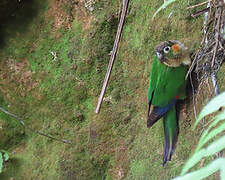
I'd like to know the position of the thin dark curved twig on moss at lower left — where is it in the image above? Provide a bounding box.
[0,107,72,144]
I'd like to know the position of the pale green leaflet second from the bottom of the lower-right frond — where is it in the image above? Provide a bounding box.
[181,136,225,175]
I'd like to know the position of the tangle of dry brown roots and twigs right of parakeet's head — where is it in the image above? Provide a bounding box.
[186,0,225,100]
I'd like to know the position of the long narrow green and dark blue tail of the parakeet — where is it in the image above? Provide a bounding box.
[163,105,179,166]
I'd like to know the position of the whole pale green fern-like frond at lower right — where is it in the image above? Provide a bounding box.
[174,92,225,180]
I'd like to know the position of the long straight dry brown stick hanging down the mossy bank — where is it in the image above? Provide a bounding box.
[95,0,129,113]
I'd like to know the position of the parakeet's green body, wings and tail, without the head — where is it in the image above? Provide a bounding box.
[147,57,187,165]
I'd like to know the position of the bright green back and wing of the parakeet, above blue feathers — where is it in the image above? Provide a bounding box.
[148,57,187,107]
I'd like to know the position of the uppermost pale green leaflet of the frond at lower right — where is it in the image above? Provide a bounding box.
[194,92,225,128]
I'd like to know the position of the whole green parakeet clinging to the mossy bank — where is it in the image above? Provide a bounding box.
[147,40,191,166]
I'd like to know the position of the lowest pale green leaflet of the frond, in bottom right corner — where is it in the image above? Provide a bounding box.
[173,158,225,180]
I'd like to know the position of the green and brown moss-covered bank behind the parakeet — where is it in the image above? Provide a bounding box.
[0,0,223,180]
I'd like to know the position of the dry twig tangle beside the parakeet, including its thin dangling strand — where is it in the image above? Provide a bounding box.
[186,0,224,124]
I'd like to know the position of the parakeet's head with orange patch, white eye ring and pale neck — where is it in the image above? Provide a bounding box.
[155,40,191,67]
